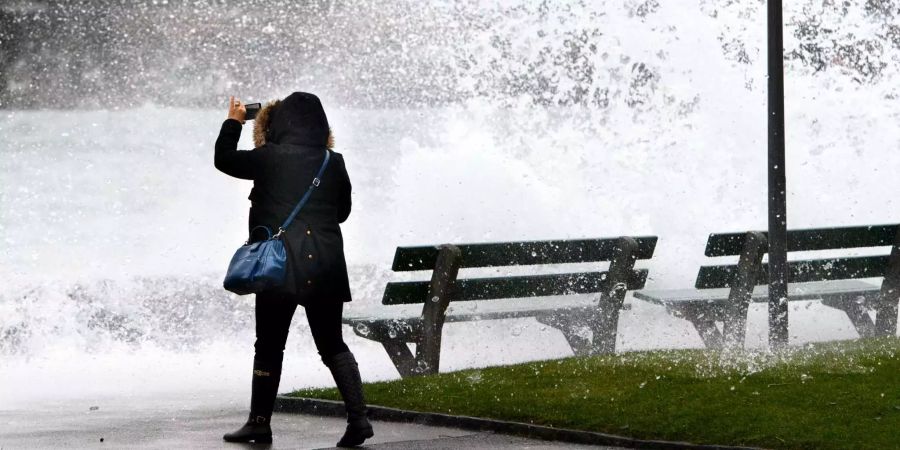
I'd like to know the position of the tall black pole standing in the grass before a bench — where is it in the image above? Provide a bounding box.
[768,0,788,349]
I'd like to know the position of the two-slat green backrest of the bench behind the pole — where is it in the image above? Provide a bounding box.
[695,225,898,289]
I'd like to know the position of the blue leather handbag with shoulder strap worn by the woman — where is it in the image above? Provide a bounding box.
[223,150,331,295]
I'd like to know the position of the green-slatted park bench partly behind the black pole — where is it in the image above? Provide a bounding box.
[634,225,900,348]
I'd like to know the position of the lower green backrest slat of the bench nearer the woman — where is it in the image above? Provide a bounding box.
[381,269,647,305]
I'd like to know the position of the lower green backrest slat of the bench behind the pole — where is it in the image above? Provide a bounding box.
[694,255,893,289]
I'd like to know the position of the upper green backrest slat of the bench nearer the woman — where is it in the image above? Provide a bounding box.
[391,236,657,272]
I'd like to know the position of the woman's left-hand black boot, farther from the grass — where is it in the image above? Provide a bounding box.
[222,360,281,443]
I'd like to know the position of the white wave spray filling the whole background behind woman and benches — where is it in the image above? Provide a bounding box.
[0,0,900,405]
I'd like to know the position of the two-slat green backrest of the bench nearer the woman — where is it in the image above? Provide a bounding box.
[382,236,657,305]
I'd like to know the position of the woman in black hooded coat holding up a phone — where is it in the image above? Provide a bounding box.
[215,92,373,447]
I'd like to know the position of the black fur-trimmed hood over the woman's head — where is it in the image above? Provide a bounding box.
[253,92,329,147]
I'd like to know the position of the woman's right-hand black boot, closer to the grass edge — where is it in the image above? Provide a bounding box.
[323,352,375,447]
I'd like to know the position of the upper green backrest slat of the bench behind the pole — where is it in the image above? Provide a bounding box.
[706,224,897,256]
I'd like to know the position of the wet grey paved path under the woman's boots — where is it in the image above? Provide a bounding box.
[0,400,620,450]
